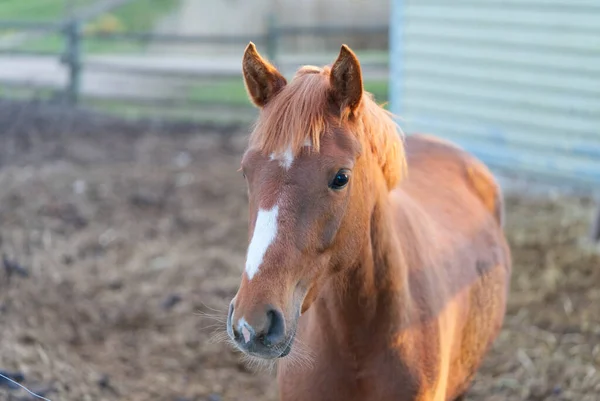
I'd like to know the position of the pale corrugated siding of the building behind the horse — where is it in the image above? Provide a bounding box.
[390,0,600,187]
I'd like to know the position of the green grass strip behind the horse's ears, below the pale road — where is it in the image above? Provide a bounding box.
[188,78,388,106]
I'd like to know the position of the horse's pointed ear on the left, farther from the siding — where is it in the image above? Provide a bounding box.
[242,42,287,108]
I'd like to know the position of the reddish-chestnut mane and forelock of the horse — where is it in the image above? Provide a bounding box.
[250,66,406,189]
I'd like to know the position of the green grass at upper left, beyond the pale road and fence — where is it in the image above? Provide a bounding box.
[0,0,180,53]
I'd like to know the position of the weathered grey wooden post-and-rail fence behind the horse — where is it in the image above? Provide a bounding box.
[0,0,388,121]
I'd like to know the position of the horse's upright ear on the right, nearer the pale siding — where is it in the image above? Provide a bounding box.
[329,45,363,114]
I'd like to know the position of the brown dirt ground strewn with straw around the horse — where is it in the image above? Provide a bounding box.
[0,104,600,401]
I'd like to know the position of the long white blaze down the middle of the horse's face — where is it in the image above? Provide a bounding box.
[246,205,279,281]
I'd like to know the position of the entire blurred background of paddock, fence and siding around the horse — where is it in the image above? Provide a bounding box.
[0,0,600,401]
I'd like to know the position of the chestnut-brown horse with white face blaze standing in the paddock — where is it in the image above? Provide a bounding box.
[227,43,511,401]
